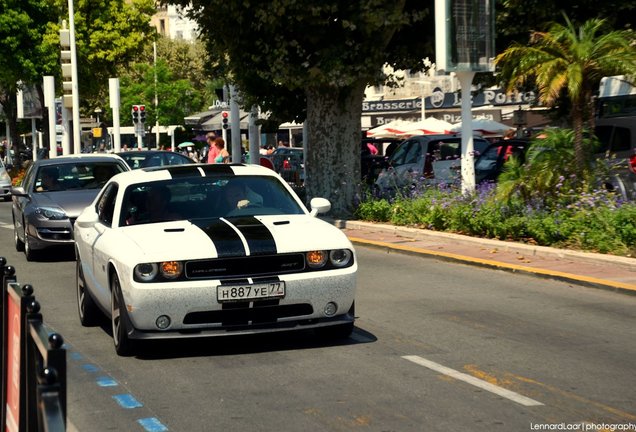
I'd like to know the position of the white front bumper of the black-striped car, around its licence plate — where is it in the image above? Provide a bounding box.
[122,268,356,339]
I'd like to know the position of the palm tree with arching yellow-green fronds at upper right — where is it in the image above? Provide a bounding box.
[495,14,636,172]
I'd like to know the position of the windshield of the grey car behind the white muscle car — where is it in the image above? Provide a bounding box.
[33,161,124,192]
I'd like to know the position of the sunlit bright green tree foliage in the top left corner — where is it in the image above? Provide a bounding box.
[0,0,156,158]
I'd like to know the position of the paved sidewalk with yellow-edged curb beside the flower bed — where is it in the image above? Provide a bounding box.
[331,220,636,295]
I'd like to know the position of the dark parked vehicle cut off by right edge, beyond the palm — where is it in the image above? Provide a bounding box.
[594,116,636,201]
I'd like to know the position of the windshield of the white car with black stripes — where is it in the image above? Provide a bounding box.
[119,176,304,226]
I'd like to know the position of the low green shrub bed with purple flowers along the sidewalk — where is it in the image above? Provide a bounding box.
[357,182,636,256]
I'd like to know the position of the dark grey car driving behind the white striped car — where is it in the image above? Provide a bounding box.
[11,154,130,261]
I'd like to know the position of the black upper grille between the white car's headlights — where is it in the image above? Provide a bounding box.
[185,253,305,279]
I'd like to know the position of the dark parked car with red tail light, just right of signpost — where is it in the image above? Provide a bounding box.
[475,138,530,183]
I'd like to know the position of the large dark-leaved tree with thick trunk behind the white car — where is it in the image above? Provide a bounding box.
[169,0,434,216]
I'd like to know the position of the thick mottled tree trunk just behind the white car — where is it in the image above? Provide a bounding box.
[305,83,364,218]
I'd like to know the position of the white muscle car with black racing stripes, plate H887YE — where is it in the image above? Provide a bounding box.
[75,164,357,355]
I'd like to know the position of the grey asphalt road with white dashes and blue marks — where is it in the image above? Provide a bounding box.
[0,203,636,432]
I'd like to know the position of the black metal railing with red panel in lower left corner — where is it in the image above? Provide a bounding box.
[0,257,66,432]
